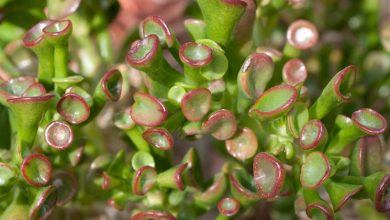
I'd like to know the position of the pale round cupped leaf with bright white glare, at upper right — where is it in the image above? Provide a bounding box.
[287,20,318,50]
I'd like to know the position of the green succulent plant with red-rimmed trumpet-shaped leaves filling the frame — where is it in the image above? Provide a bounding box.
[0,0,390,220]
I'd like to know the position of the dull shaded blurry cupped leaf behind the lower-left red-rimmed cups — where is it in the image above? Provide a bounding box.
[51,170,78,206]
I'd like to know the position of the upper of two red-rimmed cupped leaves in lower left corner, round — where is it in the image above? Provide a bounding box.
[20,154,52,187]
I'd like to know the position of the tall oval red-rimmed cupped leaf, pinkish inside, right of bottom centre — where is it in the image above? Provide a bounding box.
[253,153,285,199]
